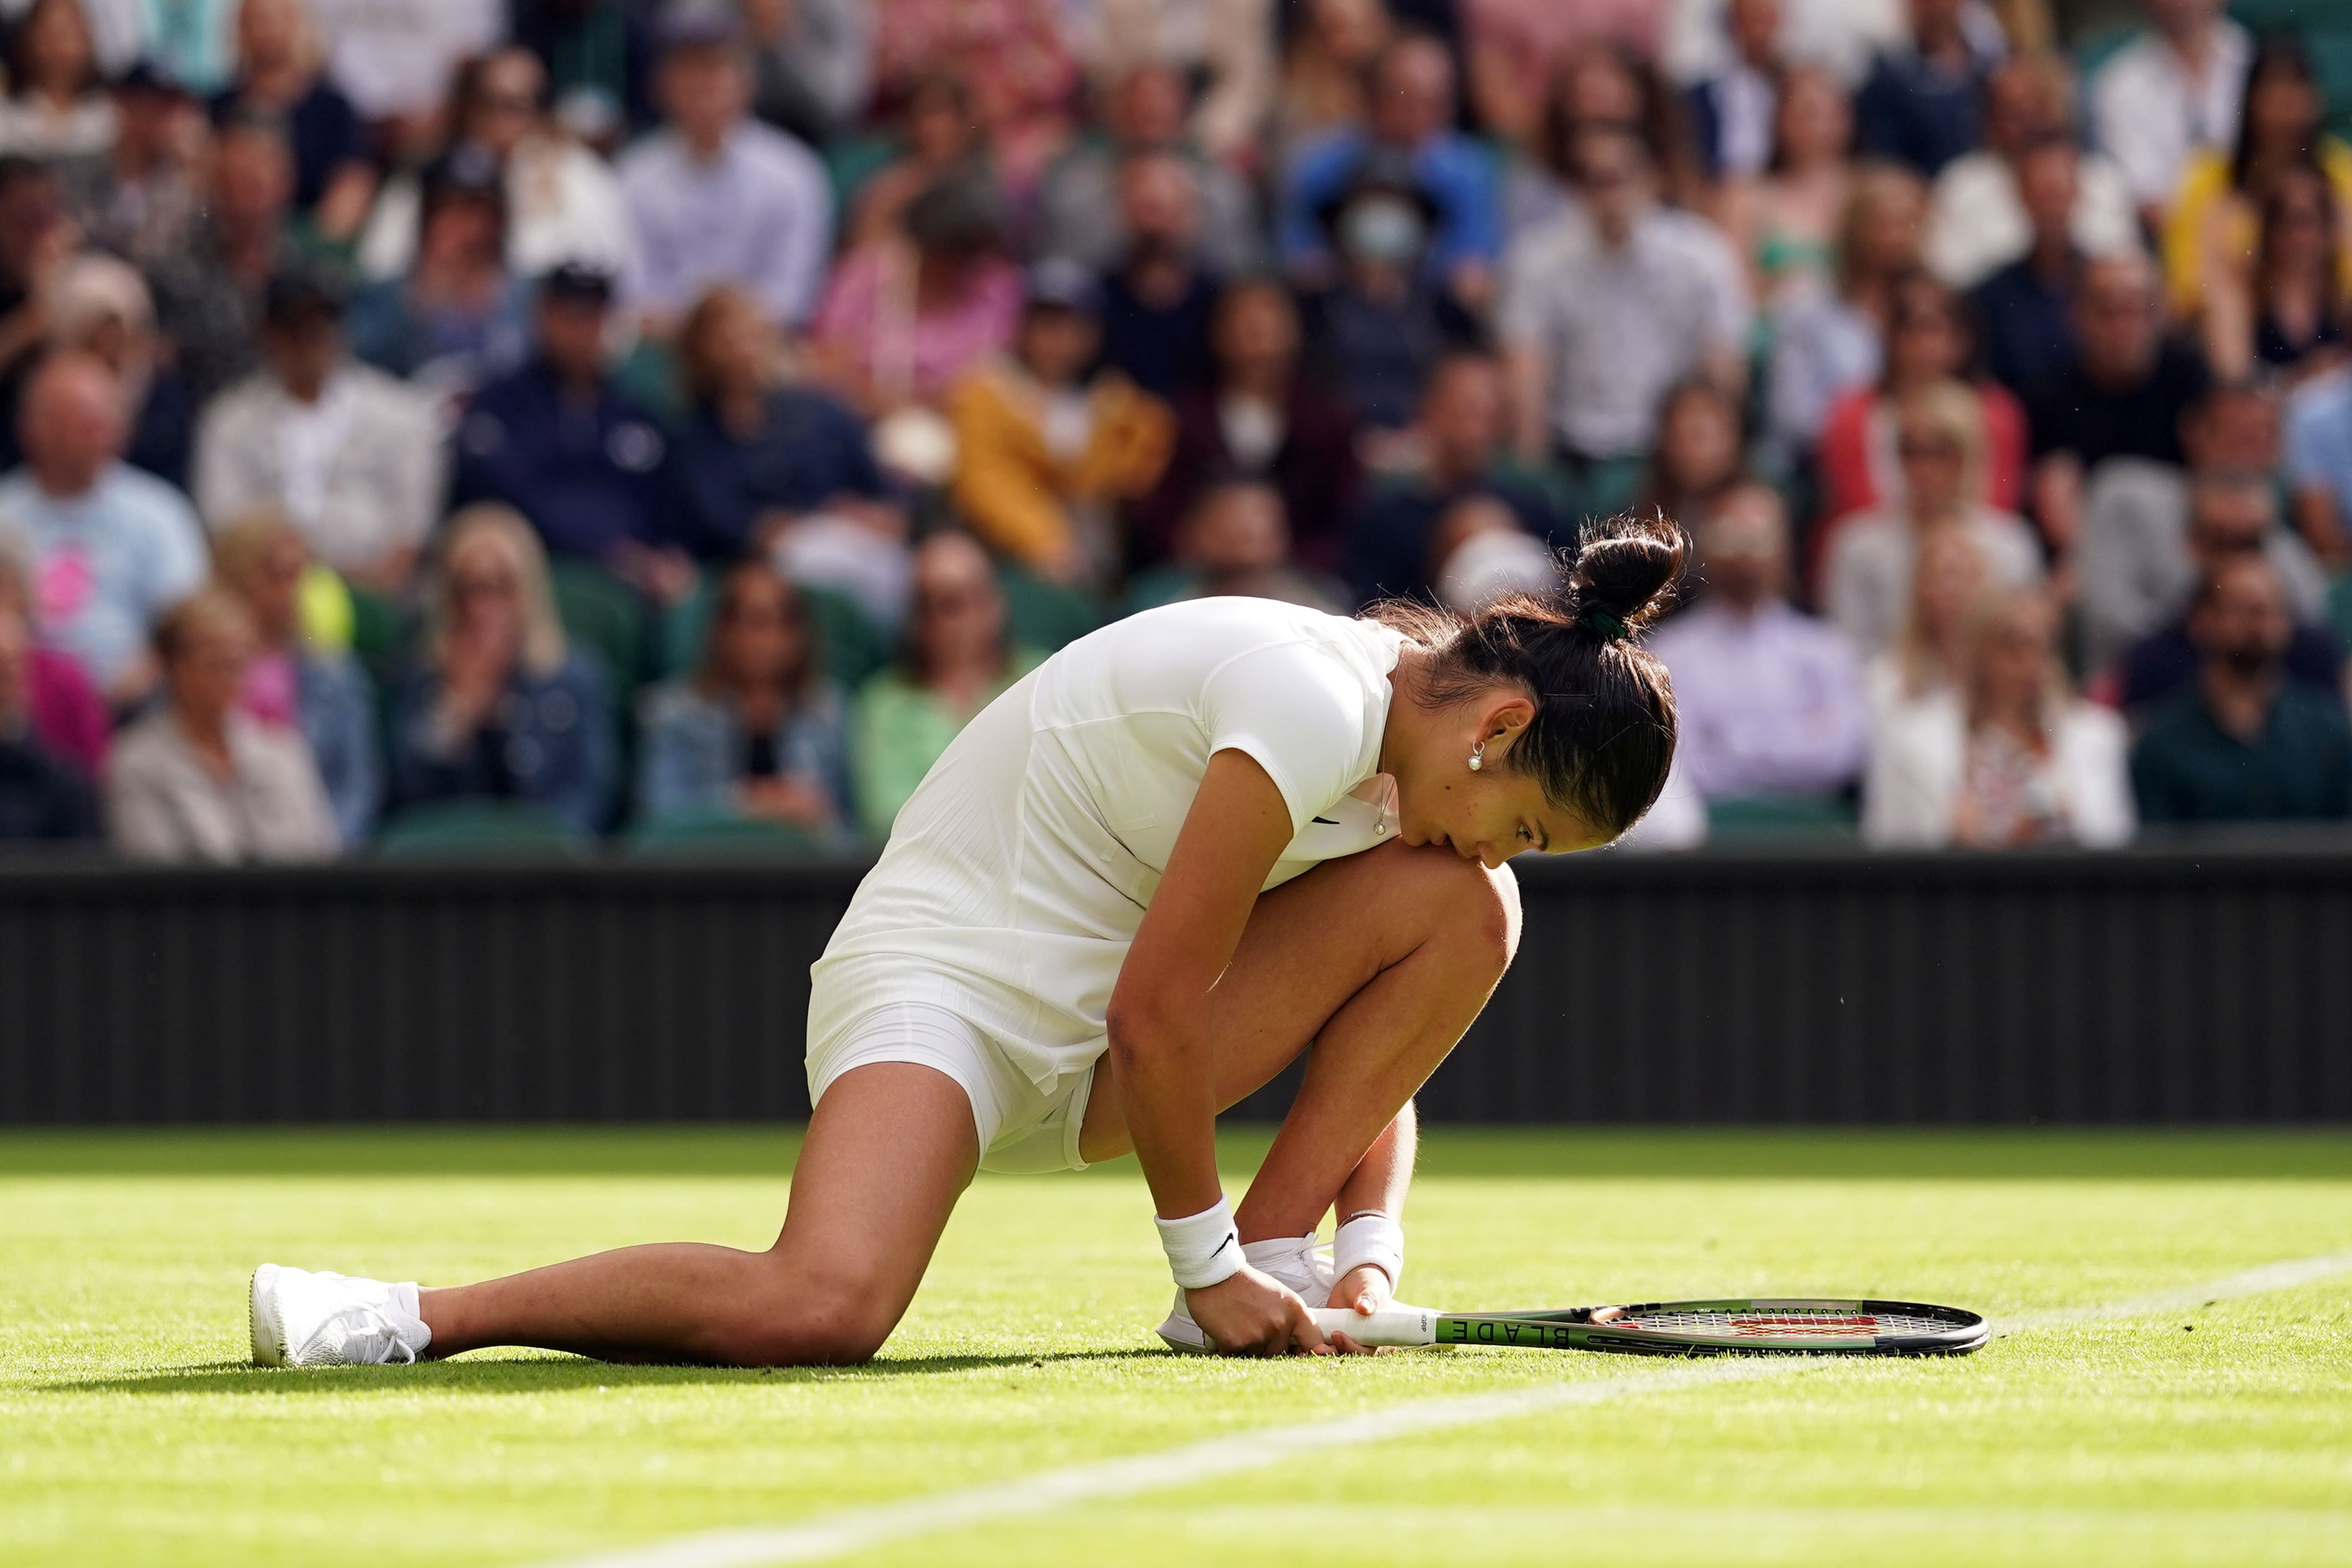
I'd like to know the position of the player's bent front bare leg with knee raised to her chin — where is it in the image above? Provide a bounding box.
[1079,844,1520,1241]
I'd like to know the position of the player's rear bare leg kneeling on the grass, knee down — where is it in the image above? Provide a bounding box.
[421,1063,981,1366]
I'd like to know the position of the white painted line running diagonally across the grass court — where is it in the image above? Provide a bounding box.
[533,1253,2352,1568]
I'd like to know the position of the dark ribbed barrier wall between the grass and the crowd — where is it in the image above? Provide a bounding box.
[0,844,2352,1123]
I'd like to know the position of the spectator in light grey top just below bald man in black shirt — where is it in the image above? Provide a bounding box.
[2079,383,2326,677]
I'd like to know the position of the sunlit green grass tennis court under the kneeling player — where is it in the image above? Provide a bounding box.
[0,1128,2352,1568]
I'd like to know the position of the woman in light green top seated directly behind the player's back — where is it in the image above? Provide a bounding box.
[849,532,1037,837]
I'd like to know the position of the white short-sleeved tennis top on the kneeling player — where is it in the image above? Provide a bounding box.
[809,597,1404,1089]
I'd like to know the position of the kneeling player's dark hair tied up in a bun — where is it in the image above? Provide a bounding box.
[1373,515,1691,837]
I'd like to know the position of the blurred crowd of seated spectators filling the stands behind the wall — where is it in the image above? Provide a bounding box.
[0,0,2352,860]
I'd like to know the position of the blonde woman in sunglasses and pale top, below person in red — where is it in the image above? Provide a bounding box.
[1823,381,2042,656]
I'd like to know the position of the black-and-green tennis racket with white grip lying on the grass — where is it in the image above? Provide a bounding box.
[1312,1298,1992,1357]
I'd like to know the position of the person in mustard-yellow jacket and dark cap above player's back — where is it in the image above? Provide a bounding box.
[948,261,1176,585]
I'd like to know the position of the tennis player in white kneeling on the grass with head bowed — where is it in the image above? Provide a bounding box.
[252,517,1686,1366]
